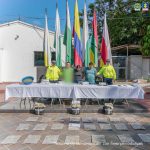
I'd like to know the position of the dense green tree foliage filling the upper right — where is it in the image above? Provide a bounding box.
[80,0,150,56]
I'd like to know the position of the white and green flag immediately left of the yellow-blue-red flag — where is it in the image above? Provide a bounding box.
[63,0,72,63]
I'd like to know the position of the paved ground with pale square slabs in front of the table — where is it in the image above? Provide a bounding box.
[0,113,150,150]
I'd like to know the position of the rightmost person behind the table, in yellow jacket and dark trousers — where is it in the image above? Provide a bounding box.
[97,59,116,85]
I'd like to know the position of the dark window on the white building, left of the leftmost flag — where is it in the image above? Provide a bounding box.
[34,52,44,66]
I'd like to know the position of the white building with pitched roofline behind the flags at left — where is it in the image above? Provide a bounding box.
[0,21,65,82]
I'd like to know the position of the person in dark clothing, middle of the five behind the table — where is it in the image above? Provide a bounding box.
[74,65,83,83]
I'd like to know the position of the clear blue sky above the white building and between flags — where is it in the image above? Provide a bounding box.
[0,0,94,32]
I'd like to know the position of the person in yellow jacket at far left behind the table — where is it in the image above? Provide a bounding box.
[46,60,61,82]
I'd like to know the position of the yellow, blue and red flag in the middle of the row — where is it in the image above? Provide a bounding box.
[73,0,82,66]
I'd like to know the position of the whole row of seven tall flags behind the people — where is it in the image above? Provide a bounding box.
[43,0,112,67]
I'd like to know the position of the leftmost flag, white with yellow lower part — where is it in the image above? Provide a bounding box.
[43,12,51,67]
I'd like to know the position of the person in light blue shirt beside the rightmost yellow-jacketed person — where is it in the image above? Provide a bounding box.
[84,62,97,84]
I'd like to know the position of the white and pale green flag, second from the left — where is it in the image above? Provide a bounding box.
[54,3,62,67]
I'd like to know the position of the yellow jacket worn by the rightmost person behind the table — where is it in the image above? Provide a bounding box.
[97,65,116,80]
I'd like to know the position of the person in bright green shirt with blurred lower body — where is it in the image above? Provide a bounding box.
[62,62,73,83]
